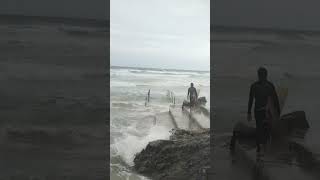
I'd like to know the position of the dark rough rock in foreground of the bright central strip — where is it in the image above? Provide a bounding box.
[134,129,210,179]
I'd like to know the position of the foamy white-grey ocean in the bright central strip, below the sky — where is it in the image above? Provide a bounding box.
[110,67,210,180]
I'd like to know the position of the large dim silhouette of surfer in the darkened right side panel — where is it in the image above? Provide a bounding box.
[248,67,280,152]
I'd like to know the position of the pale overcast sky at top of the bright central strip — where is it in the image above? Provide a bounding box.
[110,0,210,70]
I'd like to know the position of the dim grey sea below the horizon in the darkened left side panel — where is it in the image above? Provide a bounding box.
[0,17,109,180]
